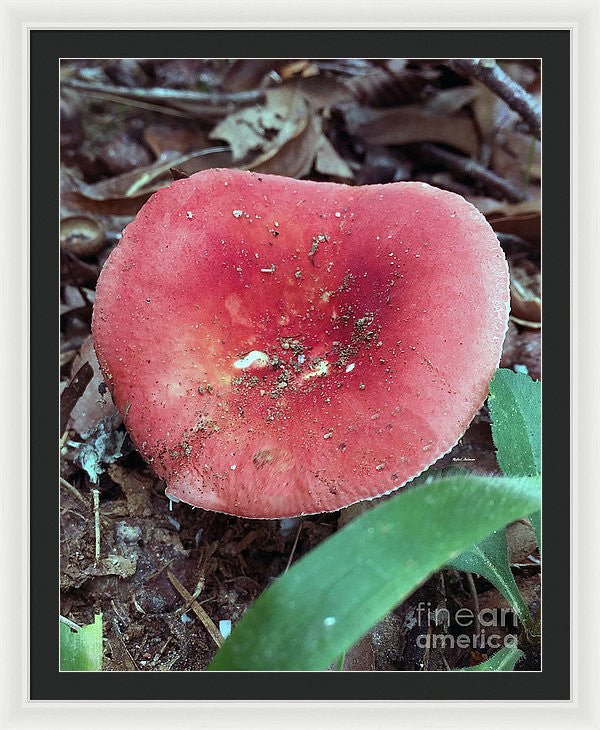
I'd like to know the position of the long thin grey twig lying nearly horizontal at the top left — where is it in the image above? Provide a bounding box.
[62,79,265,107]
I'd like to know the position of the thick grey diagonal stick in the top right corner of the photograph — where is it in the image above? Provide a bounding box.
[451,58,542,139]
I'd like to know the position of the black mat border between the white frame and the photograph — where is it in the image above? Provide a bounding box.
[32,30,571,700]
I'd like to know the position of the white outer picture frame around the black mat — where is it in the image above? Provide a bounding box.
[0,0,600,730]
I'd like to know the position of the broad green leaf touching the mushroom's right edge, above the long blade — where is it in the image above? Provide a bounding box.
[488,368,542,476]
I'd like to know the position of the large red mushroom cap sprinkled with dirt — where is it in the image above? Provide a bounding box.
[92,169,509,518]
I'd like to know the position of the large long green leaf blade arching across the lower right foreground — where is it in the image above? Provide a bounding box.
[208,474,540,671]
